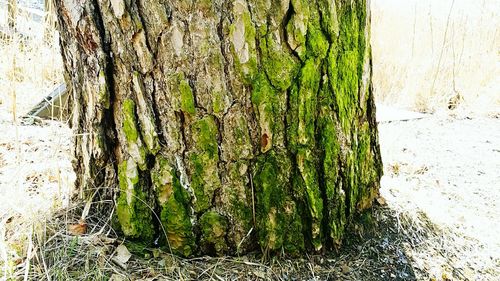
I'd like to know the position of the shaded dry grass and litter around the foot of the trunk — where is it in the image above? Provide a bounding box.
[19,199,420,280]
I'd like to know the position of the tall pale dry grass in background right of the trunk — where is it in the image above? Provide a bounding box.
[372,0,500,115]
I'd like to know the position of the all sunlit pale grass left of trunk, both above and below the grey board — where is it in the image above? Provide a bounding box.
[0,1,73,280]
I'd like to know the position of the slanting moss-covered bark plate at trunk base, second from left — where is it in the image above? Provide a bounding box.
[151,156,196,257]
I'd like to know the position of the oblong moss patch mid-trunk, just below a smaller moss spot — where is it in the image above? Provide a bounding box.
[188,116,221,212]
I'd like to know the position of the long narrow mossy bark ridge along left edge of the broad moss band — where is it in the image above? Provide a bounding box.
[287,24,329,250]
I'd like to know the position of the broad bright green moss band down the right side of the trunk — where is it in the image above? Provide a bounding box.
[287,0,373,249]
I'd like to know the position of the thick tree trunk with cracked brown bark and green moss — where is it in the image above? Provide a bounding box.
[56,0,382,256]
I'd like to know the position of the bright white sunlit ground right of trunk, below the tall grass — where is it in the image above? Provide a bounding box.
[379,108,500,280]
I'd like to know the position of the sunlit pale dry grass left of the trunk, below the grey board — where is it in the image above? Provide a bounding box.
[0,120,74,280]
